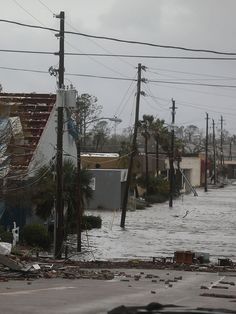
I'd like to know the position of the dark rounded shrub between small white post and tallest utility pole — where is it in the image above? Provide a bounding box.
[22,224,50,250]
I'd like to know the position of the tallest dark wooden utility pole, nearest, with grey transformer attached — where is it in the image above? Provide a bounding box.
[54,11,65,258]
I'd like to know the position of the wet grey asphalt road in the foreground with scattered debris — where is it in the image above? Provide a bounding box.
[0,270,236,314]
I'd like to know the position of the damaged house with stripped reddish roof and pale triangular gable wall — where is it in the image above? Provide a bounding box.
[0,93,76,228]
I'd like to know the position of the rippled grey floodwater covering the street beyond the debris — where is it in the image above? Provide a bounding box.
[73,185,236,260]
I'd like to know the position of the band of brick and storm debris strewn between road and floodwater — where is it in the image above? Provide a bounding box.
[0,254,236,285]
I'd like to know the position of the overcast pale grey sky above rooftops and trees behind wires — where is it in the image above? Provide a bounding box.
[0,0,236,134]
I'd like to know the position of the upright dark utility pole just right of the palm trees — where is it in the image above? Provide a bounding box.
[169,99,177,207]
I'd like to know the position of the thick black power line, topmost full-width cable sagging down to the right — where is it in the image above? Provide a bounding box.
[0,19,236,56]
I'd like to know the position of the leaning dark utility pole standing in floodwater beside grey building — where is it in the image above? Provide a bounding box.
[120,63,145,228]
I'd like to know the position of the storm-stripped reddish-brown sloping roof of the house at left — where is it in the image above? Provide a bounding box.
[0,93,56,180]
